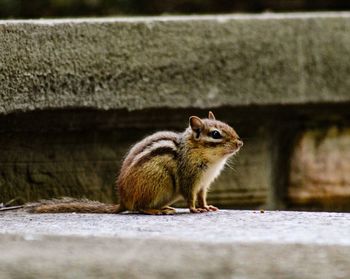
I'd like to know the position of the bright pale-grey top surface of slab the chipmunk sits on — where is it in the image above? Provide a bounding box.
[0,209,350,246]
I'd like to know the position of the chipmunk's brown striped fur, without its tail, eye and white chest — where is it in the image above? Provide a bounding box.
[117,112,242,214]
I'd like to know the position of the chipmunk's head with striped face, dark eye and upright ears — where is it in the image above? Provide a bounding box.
[189,111,243,160]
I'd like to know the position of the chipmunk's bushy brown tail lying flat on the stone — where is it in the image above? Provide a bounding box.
[24,198,126,214]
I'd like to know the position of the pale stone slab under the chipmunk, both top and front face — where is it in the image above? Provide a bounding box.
[0,210,350,279]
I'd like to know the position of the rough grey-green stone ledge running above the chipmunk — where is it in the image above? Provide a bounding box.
[0,12,350,114]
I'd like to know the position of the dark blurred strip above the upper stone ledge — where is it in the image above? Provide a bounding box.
[0,0,350,19]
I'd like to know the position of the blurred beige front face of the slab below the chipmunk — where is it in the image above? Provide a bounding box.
[0,235,350,279]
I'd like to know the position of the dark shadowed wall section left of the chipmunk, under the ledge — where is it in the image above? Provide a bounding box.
[0,131,131,206]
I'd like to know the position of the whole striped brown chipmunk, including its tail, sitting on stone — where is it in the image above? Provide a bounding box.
[32,111,243,215]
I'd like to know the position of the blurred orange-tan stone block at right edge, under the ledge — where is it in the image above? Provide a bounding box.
[288,126,350,209]
